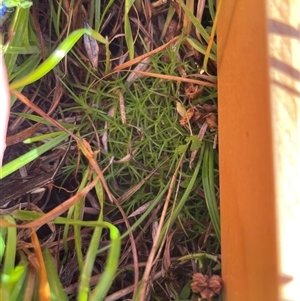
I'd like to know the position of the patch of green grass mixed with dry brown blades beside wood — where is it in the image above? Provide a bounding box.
[0,0,221,301]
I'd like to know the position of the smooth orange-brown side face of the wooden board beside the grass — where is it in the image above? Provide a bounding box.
[218,0,279,301]
